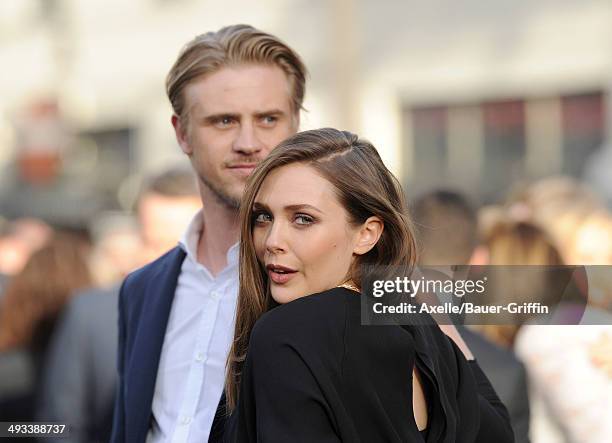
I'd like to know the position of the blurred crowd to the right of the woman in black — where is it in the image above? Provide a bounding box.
[413,177,612,443]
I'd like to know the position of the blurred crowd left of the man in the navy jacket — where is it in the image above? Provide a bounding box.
[0,169,201,442]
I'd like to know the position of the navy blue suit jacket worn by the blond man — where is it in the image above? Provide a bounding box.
[111,247,225,443]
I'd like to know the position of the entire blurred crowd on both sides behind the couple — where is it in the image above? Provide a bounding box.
[0,169,612,443]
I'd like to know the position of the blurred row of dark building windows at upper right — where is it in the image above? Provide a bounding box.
[403,91,605,203]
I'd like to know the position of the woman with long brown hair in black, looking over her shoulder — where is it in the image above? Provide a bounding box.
[226,129,513,443]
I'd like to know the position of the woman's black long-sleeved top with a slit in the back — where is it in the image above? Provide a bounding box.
[226,288,514,443]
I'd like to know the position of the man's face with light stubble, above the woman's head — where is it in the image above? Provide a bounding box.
[173,64,298,208]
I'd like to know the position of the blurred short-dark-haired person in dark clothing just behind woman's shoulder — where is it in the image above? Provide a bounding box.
[412,190,530,442]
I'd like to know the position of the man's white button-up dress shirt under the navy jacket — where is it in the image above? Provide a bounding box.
[147,212,238,443]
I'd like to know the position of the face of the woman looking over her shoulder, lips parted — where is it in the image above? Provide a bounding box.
[253,163,380,303]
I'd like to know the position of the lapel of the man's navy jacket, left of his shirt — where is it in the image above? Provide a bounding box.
[127,247,185,442]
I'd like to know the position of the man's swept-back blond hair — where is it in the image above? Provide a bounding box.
[166,25,306,125]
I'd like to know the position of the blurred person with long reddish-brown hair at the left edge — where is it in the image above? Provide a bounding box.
[0,232,92,421]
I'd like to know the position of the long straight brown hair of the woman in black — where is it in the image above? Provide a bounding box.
[226,128,416,410]
